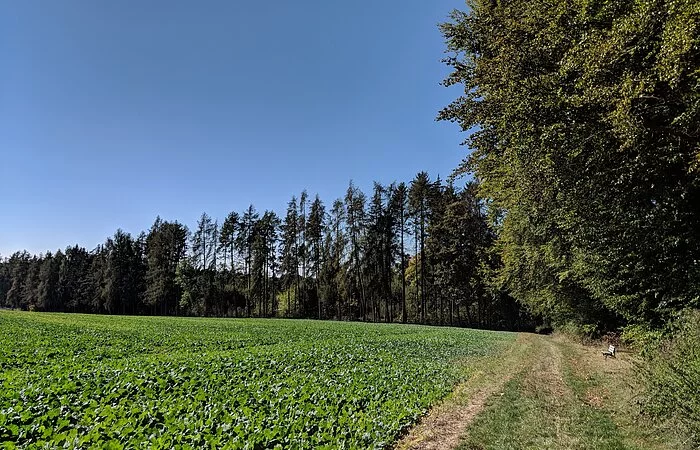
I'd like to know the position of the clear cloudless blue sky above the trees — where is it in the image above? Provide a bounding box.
[0,0,465,256]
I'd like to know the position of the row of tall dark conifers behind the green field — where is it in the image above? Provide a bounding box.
[0,172,530,329]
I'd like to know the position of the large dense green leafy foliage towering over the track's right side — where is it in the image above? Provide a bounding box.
[439,0,700,328]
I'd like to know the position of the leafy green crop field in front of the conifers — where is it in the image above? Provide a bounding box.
[0,311,514,449]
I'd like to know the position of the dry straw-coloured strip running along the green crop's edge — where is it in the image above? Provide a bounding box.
[395,334,536,450]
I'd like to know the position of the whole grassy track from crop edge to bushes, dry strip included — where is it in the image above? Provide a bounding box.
[397,334,683,450]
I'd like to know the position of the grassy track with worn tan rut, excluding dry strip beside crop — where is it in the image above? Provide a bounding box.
[454,335,682,450]
